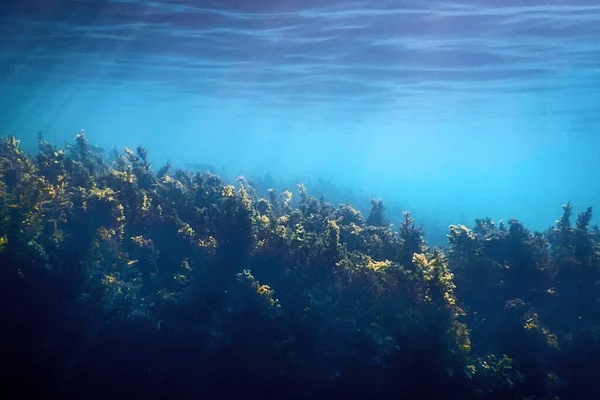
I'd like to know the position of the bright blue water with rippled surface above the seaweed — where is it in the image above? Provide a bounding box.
[0,0,600,242]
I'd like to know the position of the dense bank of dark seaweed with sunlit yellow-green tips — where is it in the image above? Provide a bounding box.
[0,132,600,399]
